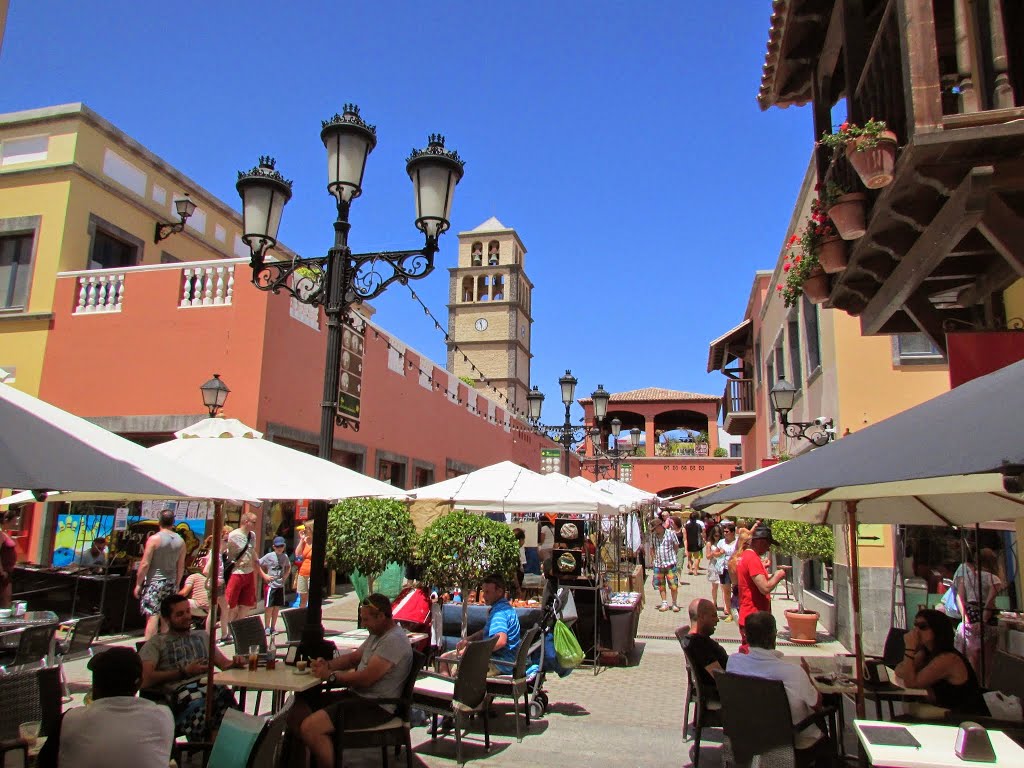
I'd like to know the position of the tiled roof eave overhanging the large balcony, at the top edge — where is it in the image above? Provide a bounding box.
[758,0,835,110]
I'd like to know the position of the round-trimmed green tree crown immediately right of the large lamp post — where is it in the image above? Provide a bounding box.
[327,499,416,592]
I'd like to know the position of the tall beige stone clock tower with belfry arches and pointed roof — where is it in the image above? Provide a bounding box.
[447,216,534,414]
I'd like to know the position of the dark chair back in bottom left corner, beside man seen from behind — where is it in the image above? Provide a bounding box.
[0,667,61,765]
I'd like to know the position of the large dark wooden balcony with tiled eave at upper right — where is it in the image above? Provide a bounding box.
[760,0,1024,349]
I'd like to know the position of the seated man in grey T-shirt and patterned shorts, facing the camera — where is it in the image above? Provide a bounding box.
[138,595,243,741]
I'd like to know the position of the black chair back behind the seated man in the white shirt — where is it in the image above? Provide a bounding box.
[715,672,839,768]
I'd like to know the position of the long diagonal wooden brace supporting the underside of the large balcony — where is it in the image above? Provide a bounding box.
[860,166,995,336]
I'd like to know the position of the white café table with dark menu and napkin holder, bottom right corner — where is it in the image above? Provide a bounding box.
[853,720,1024,768]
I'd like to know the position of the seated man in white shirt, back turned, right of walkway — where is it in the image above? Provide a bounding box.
[725,610,826,751]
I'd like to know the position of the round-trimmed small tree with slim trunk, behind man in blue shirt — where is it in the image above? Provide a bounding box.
[419,510,519,637]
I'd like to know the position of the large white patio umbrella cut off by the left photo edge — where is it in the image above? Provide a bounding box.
[0,385,256,503]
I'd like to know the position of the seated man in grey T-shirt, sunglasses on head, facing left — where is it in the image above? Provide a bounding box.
[289,593,413,768]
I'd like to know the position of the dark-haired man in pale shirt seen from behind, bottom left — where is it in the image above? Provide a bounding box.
[37,647,174,768]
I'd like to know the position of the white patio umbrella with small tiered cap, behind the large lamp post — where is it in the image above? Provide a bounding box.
[150,418,395,501]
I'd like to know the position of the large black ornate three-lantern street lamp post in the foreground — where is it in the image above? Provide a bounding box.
[236,104,465,656]
